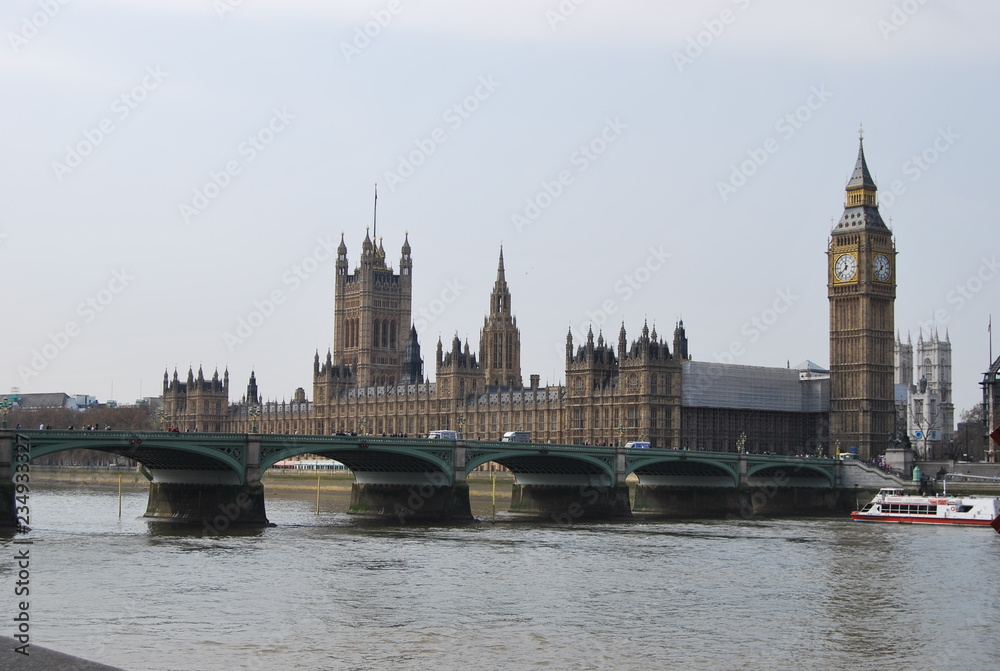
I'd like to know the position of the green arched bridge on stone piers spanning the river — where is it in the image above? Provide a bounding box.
[0,429,868,525]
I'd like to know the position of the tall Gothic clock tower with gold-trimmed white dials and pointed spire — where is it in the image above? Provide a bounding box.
[827,137,896,459]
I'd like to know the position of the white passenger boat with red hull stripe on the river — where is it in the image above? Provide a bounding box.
[851,488,1000,531]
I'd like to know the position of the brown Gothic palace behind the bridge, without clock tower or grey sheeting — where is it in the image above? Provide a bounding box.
[164,228,825,453]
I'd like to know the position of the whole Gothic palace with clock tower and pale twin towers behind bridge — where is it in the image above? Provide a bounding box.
[163,142,954,458]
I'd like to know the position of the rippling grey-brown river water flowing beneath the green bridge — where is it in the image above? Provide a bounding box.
[0,487,1000,671]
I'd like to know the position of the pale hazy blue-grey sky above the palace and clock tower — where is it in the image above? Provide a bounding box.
[0,0,1000,415]
